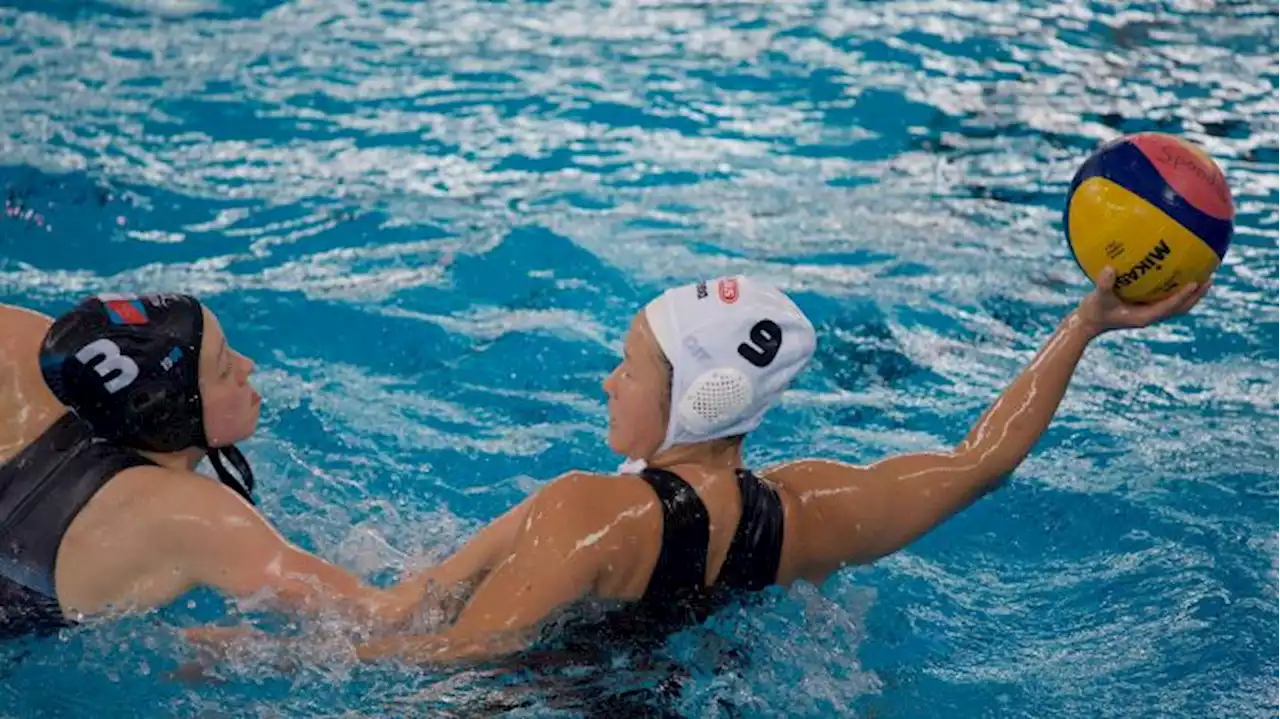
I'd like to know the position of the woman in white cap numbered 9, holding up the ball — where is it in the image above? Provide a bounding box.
[345,271,1208,661]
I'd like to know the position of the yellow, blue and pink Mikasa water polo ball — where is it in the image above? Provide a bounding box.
[1062,133,1235,303]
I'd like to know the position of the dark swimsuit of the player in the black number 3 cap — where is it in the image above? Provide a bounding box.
[0,413,154,640]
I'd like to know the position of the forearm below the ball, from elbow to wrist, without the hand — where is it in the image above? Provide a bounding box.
[956,307,1098,481]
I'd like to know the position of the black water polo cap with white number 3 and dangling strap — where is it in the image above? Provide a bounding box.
[40,294,253,502]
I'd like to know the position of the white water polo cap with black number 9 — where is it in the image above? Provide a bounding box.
[645,275,817,452]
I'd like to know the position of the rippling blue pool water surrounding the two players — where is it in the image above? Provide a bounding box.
[0,0,1280,718]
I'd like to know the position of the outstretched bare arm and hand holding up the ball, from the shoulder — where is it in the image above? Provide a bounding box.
[785,269,1208,578]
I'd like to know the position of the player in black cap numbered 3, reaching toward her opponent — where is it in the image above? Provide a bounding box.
[0,294,422,636]
